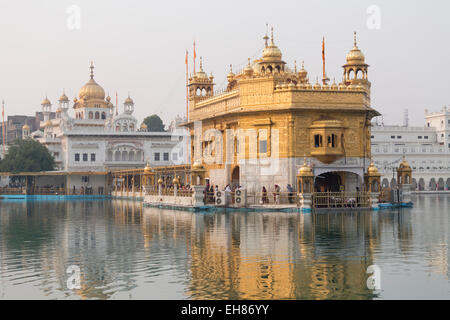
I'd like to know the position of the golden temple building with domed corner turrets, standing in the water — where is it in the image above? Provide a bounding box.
[185,31,379,191]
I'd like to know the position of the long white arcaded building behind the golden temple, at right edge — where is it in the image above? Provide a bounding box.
[372,107,450,190]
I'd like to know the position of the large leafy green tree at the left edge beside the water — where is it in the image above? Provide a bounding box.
[0,139,55,173]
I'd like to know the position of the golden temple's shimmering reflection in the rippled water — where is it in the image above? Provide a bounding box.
[138,208,380,299]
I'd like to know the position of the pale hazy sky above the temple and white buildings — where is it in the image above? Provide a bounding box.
[0,0,450,125]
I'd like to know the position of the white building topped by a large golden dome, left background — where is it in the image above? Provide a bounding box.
[28,65,186,172]
